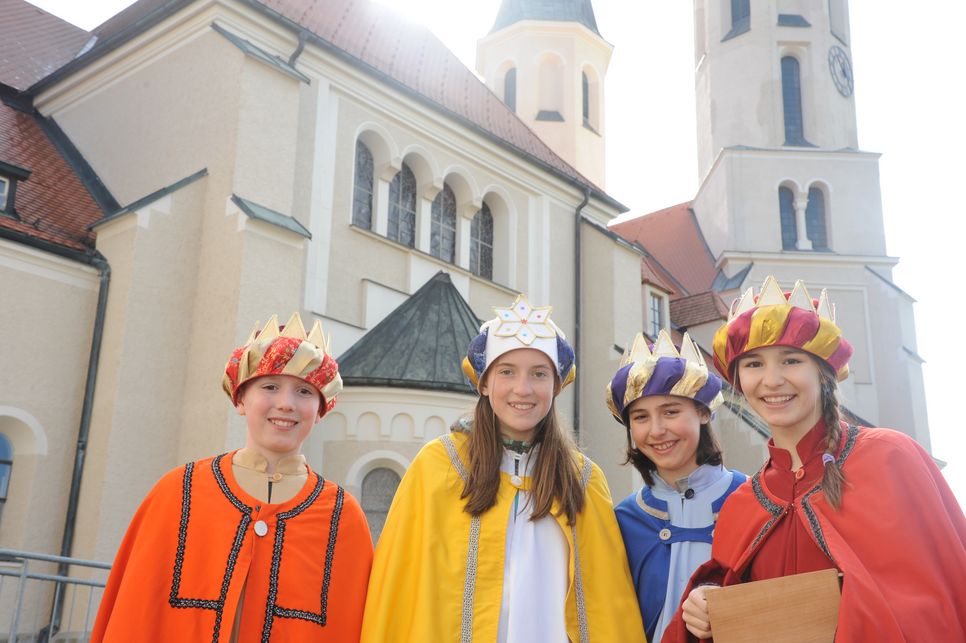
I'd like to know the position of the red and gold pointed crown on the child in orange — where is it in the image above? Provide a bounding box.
[221,313,342,417]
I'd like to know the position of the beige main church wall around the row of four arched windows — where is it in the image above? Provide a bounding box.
[15,2,641,584]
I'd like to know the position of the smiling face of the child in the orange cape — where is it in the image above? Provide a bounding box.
[235,375,322,462]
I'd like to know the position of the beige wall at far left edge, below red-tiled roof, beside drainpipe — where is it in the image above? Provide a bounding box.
[0,240,99,553]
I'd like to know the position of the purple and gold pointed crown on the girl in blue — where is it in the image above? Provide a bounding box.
[607,330,723,424]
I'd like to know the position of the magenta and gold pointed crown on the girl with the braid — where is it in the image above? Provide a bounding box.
[714,276,852,384]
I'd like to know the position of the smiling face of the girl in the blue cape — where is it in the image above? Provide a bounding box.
[627,395,711,484]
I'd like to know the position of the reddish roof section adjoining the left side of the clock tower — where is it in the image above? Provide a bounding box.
[610,202,718,296]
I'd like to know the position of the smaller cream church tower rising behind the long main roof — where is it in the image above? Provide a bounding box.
[476,0,613,188]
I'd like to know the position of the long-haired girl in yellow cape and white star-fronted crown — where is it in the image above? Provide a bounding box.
[362,295,644,643]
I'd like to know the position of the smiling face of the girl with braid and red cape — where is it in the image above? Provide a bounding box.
[735,346,822,448]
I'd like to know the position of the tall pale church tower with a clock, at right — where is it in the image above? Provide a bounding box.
[692,0,929,448]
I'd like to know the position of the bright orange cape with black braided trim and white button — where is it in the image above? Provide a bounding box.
[91,454,372,643]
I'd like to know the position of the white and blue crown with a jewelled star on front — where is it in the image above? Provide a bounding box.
[463,295,577,391]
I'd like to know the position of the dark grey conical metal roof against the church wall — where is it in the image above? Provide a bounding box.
[338,271,480,393]
